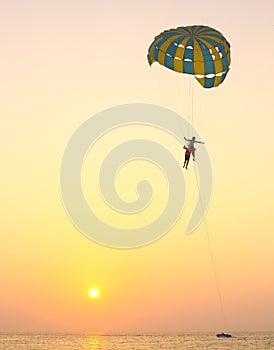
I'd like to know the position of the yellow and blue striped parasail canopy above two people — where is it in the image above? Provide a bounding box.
[147,25,230,88]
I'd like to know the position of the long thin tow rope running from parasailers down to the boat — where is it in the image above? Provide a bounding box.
[193,162,226,329]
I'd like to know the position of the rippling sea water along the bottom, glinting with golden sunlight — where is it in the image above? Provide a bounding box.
[0,332,274,350]
